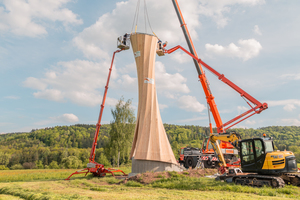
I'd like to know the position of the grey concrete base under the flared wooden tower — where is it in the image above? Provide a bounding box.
[131,158,185,175]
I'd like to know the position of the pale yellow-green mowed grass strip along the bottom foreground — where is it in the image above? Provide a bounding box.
[0,179,299,200]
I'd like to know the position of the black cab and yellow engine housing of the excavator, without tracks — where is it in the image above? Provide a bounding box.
[240,137,298,174]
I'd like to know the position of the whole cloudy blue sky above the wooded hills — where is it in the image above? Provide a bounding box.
[0,0,300,134]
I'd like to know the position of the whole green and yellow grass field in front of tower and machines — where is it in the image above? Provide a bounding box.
[0,167,300,200]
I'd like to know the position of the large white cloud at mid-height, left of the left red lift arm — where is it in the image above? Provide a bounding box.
[24,60,117,106]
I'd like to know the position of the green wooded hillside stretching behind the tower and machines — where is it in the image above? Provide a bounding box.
[0,124,300,170]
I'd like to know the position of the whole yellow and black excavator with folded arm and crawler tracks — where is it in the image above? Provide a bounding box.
[210,132,300,188]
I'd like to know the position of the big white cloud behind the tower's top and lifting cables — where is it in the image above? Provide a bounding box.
[73,0,264,62]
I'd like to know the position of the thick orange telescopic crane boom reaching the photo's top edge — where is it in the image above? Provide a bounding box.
[172,0,224,133]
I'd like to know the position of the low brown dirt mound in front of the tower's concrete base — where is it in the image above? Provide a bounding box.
[124,168,218,184]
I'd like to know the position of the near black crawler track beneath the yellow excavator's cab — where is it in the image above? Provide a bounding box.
[232,174,285,188]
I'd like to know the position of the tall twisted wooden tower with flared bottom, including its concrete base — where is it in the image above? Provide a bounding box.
[130,33,178,173]
